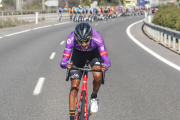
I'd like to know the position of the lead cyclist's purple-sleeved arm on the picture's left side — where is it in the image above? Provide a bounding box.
[60,31,74,68]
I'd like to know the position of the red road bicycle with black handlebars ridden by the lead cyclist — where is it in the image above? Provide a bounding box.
[66,61,105,120]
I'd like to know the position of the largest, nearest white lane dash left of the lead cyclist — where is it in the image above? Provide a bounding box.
[33,77,45,95]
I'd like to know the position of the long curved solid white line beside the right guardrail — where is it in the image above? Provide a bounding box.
[126,20,180,71]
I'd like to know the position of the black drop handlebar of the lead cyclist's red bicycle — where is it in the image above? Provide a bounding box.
[66,67,105,84]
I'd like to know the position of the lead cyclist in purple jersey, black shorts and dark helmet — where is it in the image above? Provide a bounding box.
[60,22,111,120]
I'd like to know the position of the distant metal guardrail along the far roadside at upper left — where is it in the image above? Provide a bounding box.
[0,9,68,15]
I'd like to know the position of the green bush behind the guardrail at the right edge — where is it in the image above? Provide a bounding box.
[152,4,180,31]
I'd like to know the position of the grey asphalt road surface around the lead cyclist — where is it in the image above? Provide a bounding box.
[0,16,180,120]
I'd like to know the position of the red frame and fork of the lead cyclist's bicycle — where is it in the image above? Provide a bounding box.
[76,72,89,120]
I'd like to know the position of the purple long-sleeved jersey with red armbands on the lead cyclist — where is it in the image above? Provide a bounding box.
[60,28,111,71]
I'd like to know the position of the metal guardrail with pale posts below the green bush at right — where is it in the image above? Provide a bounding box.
[143,15,180,53]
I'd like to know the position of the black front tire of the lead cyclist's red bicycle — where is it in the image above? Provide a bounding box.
[78,91,86,120]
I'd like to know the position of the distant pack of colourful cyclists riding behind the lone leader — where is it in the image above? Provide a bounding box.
[69,5,145,22]
